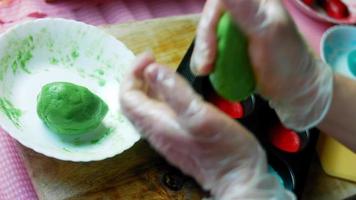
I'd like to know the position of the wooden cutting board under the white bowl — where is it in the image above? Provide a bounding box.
[21,15,202,200]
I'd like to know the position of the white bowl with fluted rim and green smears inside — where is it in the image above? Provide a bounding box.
[0,19,140,161]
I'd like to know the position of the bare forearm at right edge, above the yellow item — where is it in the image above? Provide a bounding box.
[318,74,356,152]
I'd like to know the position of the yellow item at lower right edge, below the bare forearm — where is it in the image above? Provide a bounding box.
[317,134,356,182]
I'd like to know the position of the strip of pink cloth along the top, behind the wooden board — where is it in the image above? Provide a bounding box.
[0,0,205,31]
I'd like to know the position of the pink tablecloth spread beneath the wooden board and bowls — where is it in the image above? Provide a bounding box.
[0,0,331,200]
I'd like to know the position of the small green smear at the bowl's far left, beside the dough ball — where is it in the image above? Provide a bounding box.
[0,98,22,128]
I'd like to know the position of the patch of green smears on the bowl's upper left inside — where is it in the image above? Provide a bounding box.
[0,35,35,80]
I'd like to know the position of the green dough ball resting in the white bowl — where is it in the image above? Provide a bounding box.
[37,82,108,135]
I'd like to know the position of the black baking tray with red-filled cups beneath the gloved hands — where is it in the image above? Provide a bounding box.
[177,43,319,199]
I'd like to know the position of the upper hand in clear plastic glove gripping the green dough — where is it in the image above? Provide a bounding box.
[191,0,333,131]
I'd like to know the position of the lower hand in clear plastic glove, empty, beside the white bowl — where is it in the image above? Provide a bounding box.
[120,54,294,200]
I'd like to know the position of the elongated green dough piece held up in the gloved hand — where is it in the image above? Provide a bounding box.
[209,13,255,101]
